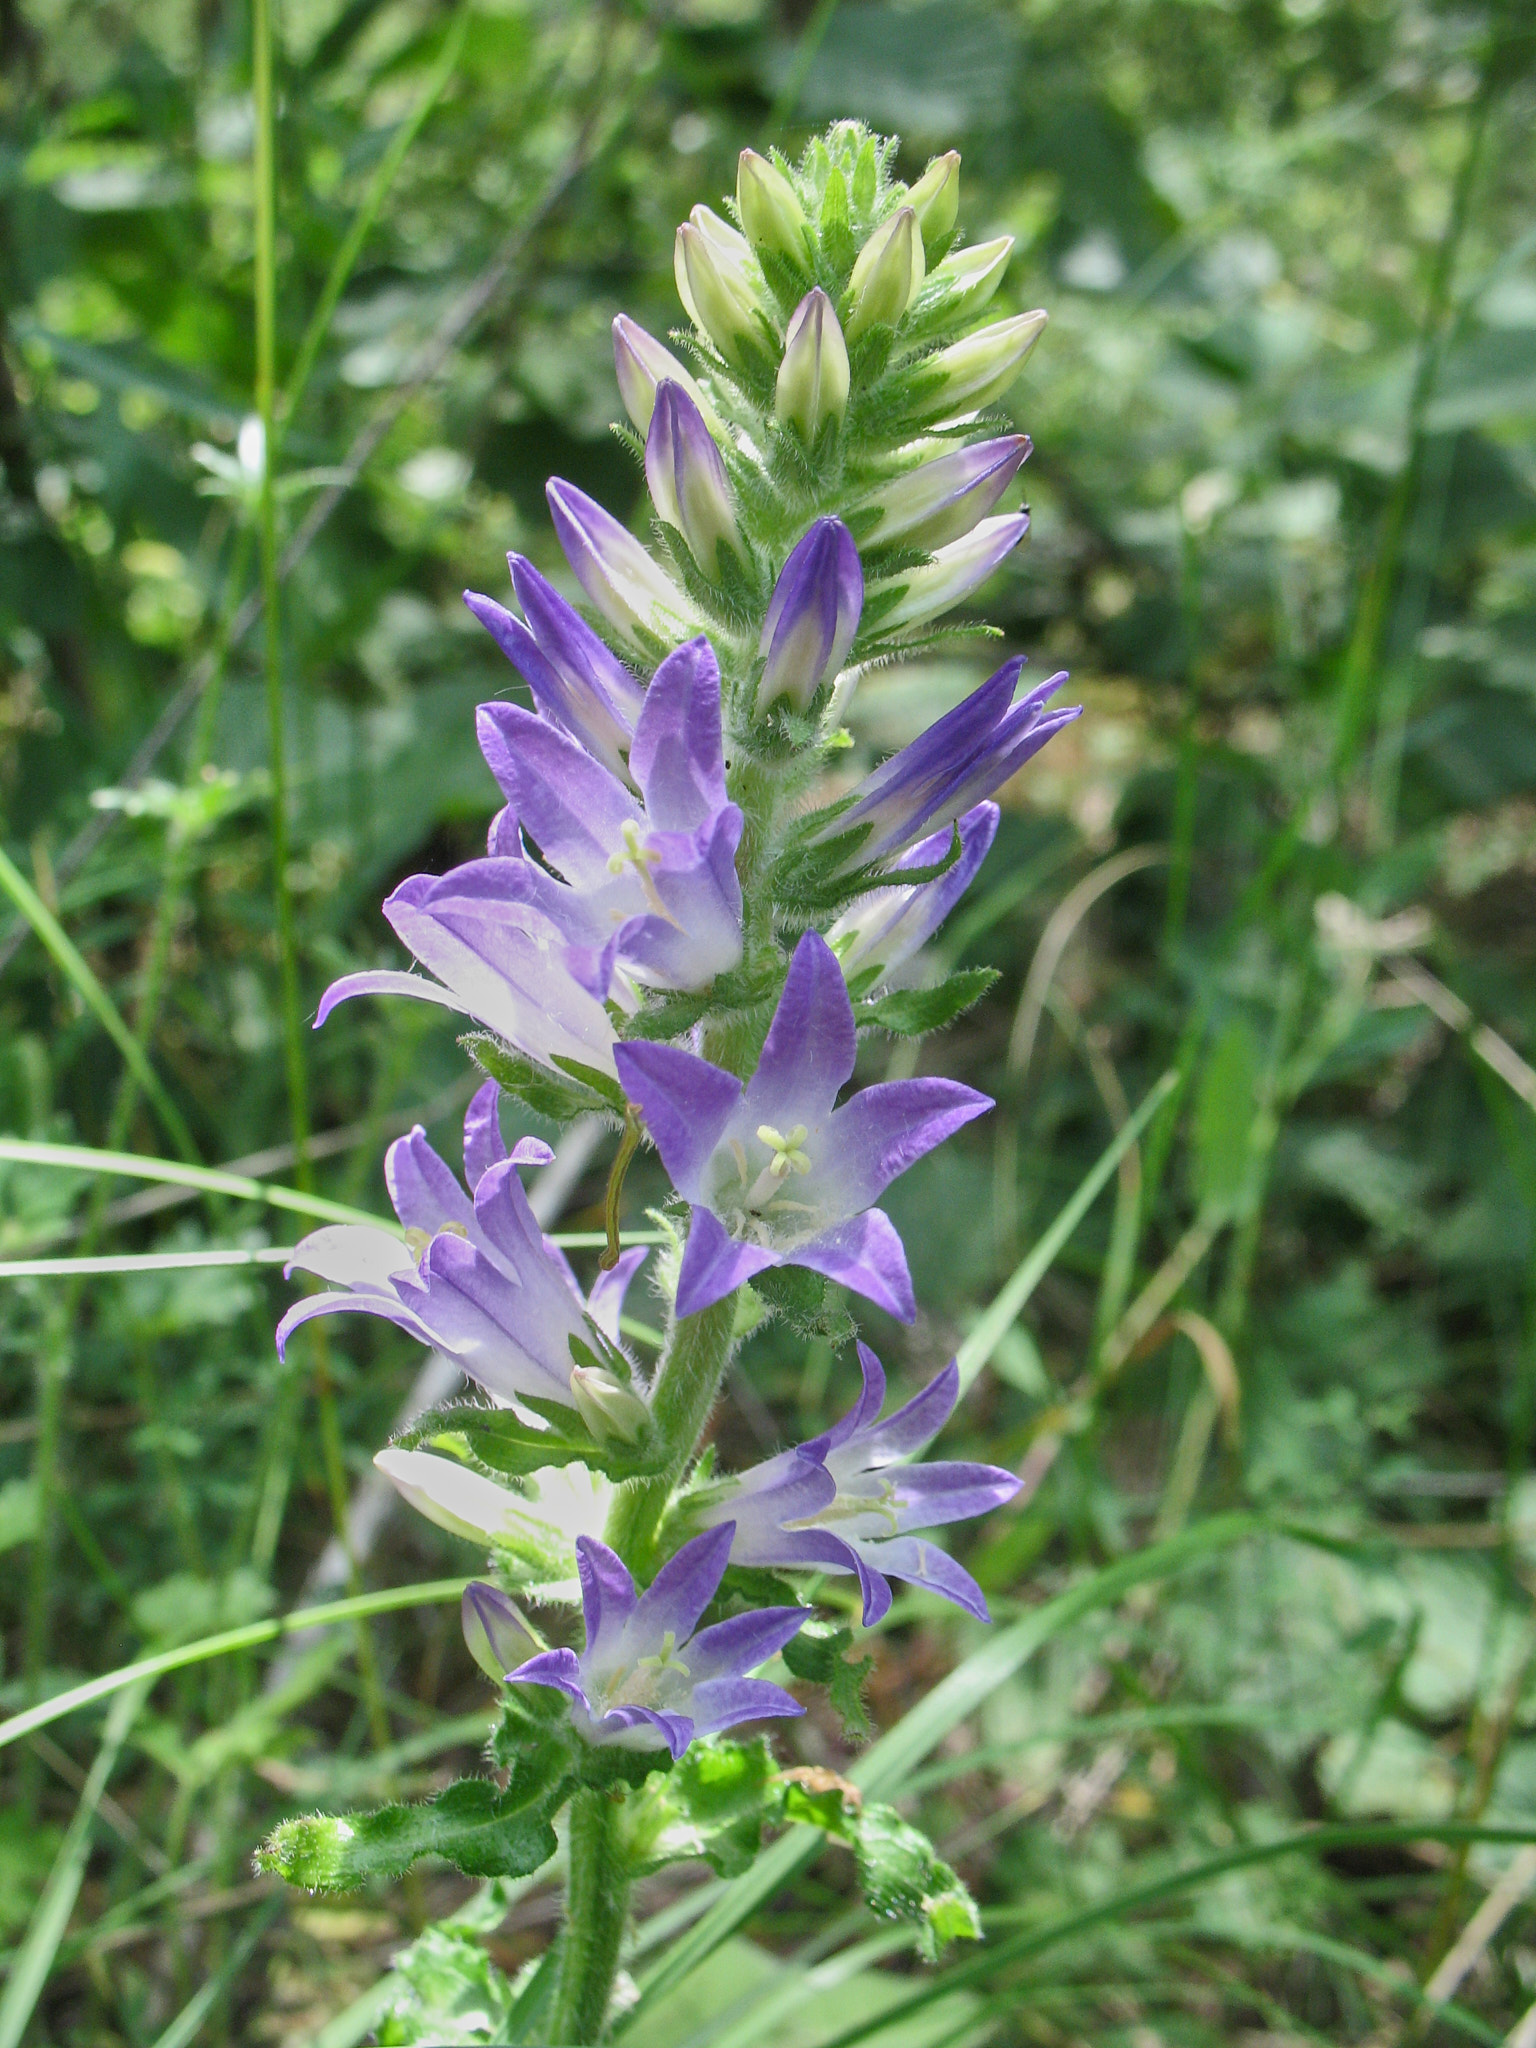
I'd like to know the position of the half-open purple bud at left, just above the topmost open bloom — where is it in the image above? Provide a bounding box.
[465,555,645,776]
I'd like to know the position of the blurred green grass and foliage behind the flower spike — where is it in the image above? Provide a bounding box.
[0,0,1536,2048]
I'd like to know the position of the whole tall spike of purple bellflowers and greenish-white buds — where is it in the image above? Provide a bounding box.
[279,123,1077,1990]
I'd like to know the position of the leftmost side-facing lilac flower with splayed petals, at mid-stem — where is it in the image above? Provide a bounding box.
[276,1081,645,1407]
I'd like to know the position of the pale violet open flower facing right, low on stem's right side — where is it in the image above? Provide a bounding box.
[705,1343,1020,1628]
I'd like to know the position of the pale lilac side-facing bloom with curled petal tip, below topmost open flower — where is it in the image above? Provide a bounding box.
[315,864,616,1075]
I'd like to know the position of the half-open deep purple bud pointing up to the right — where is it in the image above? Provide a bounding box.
[817,655,1081,866]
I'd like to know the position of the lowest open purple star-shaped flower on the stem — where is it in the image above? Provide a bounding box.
[495,1522,807,1757]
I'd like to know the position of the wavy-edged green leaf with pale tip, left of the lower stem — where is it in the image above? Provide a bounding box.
[256,1743,567,1892]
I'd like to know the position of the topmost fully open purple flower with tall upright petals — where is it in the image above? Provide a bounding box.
[479,630,741,1004]
